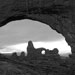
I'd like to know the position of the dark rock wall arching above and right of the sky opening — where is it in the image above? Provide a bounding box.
[0,0,75,53]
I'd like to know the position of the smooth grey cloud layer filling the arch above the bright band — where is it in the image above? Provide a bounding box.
[0,20,63,46]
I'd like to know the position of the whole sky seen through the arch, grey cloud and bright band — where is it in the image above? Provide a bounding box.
[0,19,71,53]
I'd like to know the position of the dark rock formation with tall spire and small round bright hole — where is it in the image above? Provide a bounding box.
[27,41,59,60]
